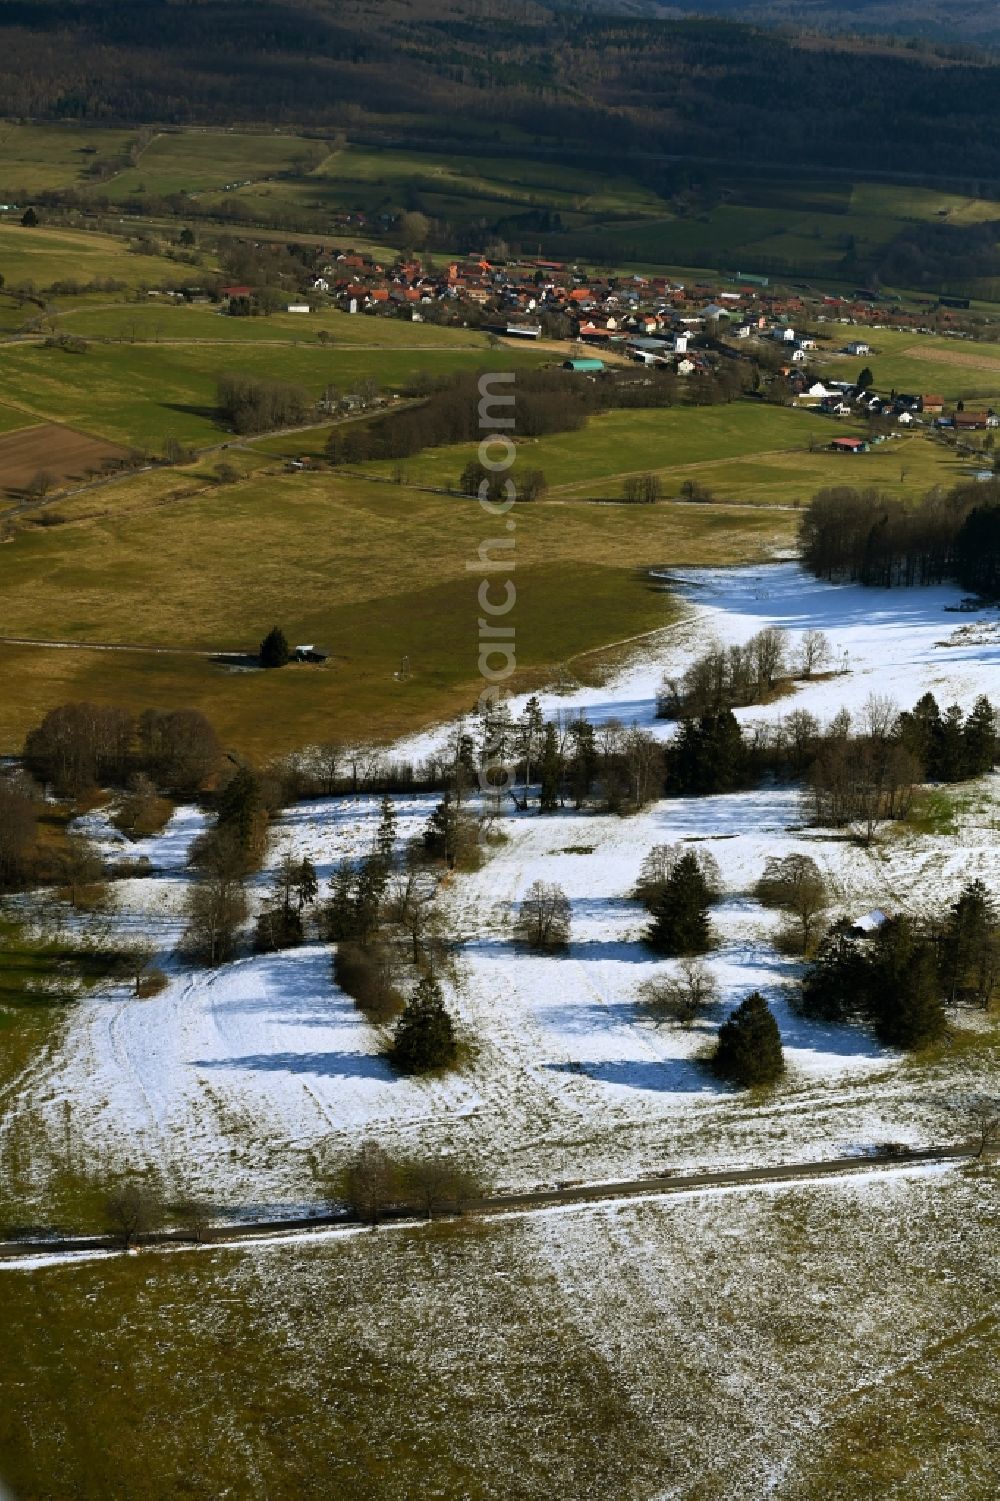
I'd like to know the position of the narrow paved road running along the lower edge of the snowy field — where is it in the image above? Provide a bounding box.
[0,1142,979,1265]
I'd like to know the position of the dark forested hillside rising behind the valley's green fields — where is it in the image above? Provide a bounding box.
[0,0,1000,182]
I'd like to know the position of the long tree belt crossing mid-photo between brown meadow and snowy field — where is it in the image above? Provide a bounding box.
[0,678,998,906]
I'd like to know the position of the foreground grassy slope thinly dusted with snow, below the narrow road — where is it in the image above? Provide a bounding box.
[0,1172,1000,1501]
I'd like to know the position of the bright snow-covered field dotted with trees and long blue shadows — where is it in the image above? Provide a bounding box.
[2,563,1000,1208]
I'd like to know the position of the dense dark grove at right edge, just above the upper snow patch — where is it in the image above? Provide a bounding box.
[800,479,1000,599]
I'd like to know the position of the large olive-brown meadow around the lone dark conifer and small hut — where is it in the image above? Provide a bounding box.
[0,474,791,752]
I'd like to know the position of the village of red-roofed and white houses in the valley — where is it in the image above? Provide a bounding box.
[202,246,1000,453]
